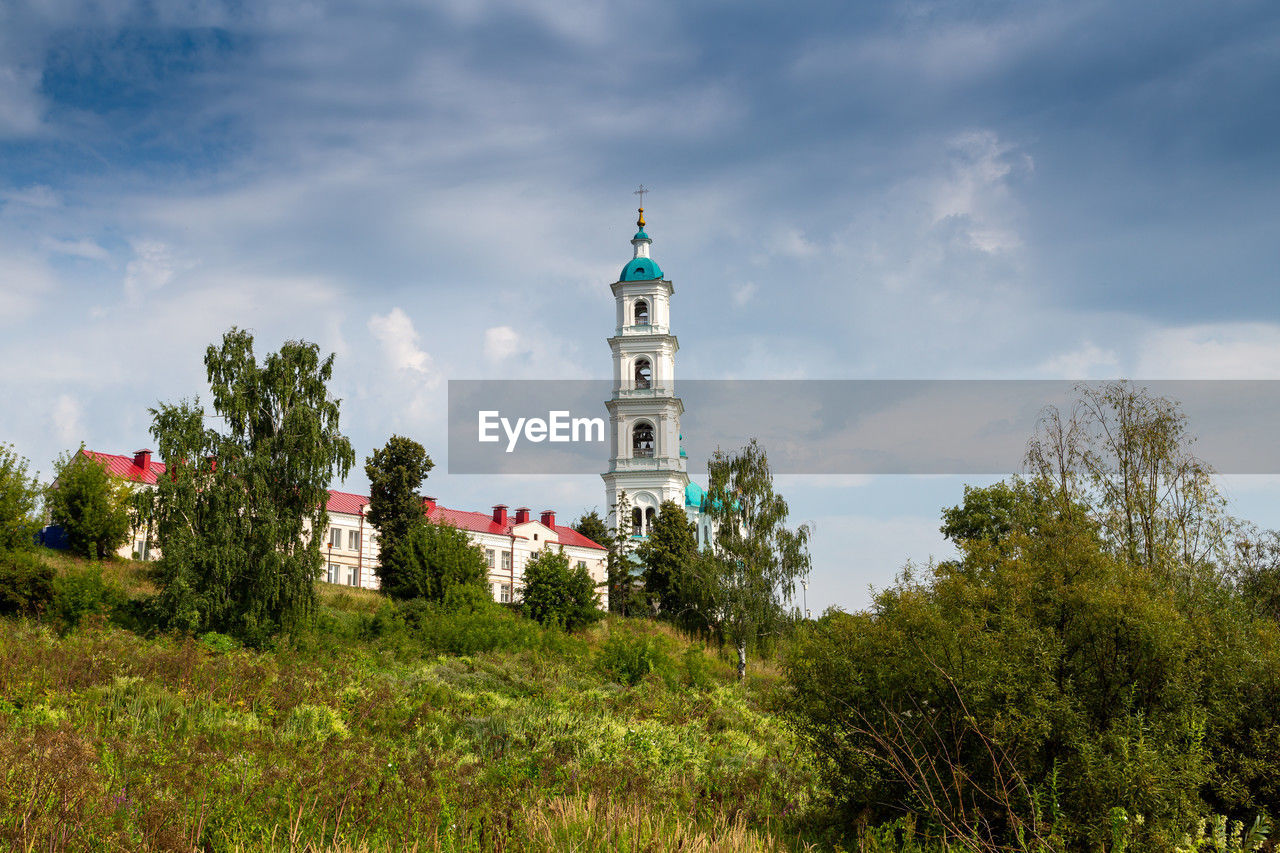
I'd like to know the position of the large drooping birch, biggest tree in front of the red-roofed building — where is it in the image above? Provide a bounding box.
[150,328,355,644]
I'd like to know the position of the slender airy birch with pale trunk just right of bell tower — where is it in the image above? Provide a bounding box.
[700,438,810,680]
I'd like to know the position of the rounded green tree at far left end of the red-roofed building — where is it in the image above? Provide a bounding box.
[46,444,132,558]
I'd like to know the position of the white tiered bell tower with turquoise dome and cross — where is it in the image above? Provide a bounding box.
[600,202,689,535]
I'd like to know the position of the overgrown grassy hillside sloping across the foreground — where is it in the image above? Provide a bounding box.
[0,557,817,850]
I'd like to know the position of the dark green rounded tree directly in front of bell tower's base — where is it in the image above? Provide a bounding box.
[636,501,703,625]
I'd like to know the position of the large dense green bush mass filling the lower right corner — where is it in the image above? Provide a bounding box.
[785,483,1280,849]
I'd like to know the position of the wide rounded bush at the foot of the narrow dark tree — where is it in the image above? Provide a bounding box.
[378,516,488,602]
